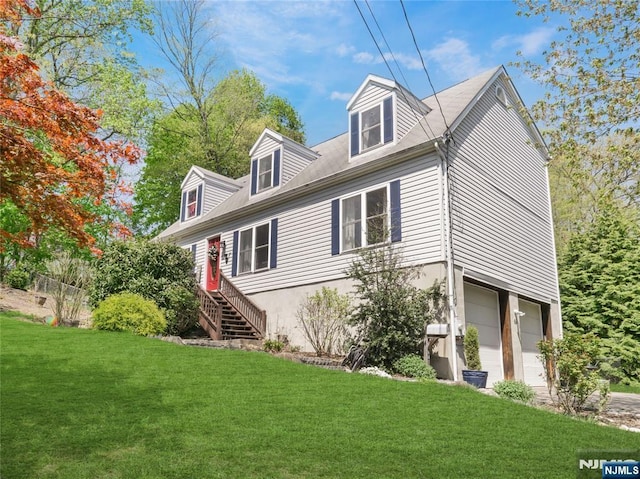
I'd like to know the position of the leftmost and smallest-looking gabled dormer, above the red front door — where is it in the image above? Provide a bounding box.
[180,166,242,223]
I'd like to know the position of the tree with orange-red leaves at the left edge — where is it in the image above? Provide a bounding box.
[0,0,141,253]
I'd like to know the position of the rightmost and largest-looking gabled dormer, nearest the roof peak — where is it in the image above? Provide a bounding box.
[347,75,431,158]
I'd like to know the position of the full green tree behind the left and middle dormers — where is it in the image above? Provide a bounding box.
[134,70,304,234]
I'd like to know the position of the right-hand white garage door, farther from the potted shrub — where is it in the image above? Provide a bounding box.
[518,299,546,386]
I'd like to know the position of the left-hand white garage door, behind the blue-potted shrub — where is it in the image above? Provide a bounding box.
[464,283,503,387]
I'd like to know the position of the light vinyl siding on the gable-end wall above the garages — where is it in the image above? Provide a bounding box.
[450,79,557,301]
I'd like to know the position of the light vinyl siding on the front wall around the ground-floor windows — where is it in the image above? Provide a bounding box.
[204,157,443,294]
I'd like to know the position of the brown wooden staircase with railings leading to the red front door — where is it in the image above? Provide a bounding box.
[196,274,267,340]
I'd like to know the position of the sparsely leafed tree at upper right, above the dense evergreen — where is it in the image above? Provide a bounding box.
[517,0,640,252]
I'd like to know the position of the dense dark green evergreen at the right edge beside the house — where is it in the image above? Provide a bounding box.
[559,206,640,382]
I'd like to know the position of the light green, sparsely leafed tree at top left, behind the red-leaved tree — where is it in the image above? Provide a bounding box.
[14,0,157,142]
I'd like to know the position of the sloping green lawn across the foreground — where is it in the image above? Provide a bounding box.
[0,313,640,479]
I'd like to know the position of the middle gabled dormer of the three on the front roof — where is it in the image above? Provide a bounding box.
[249,128,318,196]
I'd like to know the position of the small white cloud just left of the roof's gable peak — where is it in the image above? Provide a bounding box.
[424,38,485,81]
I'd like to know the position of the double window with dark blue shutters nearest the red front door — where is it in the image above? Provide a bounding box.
[231,218,278,276]
